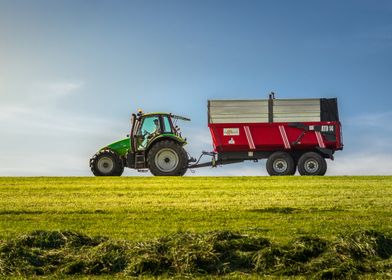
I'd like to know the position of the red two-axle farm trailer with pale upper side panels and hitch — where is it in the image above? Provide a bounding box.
[189,94,343,175]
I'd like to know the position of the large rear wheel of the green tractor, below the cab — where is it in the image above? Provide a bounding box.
[147,140,188,176]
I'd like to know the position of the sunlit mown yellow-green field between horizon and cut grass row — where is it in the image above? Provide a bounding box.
[0,177,392,278]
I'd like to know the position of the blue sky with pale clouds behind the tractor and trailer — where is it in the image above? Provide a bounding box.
[0,0,392,176]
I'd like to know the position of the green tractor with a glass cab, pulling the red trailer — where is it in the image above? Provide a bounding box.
[90,111,190,176]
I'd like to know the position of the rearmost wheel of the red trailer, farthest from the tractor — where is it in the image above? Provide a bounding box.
[298,152,327,176]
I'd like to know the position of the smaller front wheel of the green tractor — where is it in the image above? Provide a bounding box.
[90,149,124,176]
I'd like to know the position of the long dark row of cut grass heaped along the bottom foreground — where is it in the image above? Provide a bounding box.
[0,230,392,279]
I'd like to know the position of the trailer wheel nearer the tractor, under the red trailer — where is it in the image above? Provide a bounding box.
[267,152,295,176]
